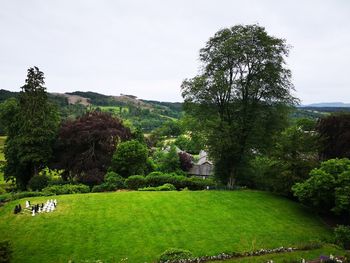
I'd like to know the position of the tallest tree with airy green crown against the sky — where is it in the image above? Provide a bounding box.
[182,25,296,186]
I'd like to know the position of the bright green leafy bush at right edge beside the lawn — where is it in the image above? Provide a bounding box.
[292,158,350,216]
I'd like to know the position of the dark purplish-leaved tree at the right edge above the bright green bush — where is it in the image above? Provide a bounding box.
[317,113,350,160]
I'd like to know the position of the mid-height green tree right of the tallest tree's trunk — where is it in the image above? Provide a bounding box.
[248,119,318,197]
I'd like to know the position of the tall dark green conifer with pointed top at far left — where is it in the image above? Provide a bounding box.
[0,67,59,188]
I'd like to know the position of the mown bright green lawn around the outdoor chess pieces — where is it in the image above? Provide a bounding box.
[0,191,331,263]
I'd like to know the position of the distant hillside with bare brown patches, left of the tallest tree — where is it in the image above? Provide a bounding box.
[0,90,182,133]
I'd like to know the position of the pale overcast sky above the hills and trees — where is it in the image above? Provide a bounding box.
[0,0,350,104]
